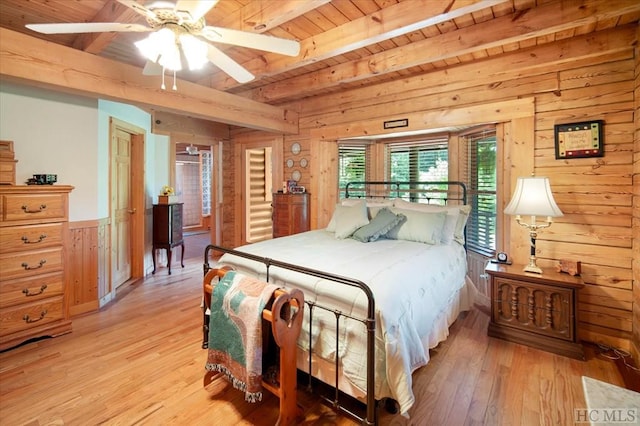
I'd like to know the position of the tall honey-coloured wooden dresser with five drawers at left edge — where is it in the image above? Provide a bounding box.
[0,185,73,350]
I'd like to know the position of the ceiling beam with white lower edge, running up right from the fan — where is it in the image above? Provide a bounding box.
[208,0,507,90]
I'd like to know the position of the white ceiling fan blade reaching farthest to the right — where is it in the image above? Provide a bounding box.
[200,26,300,56]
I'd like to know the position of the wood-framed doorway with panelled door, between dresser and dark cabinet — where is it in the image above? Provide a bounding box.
[108,118,145,292]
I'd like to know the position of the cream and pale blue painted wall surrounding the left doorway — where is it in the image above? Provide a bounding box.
[0,82,170,222]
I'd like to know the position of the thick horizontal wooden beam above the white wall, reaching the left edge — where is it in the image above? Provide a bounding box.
[0,28,298,134]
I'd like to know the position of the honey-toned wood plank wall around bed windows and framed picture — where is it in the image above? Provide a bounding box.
[225,25,639,350]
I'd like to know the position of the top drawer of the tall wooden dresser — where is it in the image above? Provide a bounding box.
[1,193,67,223]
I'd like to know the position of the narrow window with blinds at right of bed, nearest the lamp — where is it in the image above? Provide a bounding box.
[461,129,497,256]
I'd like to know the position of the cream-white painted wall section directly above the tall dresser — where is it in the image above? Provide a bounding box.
[0,82,100,221]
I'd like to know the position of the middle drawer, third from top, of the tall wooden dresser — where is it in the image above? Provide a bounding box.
[0,247,63,282]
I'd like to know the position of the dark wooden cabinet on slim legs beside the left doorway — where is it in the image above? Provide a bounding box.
[152,203,184,275]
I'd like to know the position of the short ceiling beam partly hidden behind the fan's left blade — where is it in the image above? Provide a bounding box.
[73,0,140,54]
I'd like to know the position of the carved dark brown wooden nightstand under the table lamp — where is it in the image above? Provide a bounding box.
[486,264,584,359]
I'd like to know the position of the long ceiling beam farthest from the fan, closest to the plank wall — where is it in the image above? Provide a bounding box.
[238,0,640,103]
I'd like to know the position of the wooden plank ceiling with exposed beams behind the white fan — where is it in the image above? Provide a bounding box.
[0,0,640,105]
